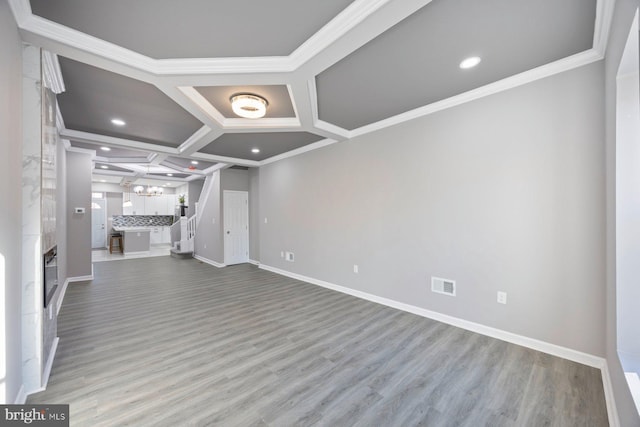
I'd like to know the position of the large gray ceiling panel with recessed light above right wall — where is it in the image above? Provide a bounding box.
[316,0,596,129]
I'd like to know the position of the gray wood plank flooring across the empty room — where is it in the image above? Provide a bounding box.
[29,257,608,427]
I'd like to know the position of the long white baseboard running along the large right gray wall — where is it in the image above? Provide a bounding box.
[260,264,606,369]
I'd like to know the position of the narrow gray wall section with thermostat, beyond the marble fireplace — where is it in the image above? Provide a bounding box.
[66,151,92,277]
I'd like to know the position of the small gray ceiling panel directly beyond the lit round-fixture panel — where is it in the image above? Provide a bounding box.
[200,132,324,161]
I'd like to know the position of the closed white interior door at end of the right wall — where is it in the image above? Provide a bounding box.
[222,190,249,265]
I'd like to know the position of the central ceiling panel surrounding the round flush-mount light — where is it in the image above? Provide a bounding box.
[195,85,296,118]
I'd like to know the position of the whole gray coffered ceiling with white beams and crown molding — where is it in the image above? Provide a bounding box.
[9,0,613,187]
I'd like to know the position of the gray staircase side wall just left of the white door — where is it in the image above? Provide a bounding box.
[194,171,224,264]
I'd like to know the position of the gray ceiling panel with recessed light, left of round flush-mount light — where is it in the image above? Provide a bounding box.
[58,58,202,147]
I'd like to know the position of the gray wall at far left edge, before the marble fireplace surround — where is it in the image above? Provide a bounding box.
[0,1,22,403]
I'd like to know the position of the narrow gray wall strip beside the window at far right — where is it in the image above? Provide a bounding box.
[605,0,640,427]
